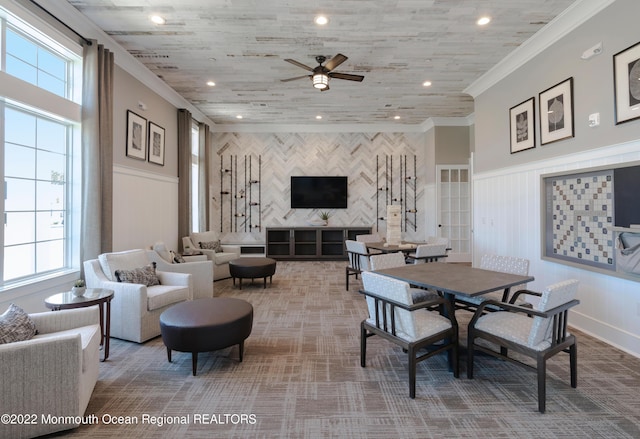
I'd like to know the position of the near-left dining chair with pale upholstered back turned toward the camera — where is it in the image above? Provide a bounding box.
[360,272,459,399]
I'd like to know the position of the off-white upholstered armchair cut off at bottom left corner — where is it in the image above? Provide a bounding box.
[0,305,100,438]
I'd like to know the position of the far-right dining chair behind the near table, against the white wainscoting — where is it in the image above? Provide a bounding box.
[455,254,531,311]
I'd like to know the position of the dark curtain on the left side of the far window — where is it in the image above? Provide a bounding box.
[178,108,192,248]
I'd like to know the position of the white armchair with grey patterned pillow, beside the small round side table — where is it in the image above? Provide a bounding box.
[84,249,193,343]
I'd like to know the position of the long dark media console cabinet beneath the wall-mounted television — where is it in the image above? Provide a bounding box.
[267,227,371,261]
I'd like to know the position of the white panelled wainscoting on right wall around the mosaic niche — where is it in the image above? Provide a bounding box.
[473,140,640,357]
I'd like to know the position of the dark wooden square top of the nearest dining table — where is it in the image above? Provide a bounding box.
[374,262,534,297]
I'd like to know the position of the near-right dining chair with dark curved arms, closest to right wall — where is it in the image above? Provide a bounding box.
[467,279,580,413]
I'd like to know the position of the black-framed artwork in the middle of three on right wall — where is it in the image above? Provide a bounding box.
[538,77,574,145]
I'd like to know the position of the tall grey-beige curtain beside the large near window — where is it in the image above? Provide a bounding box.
[80,41,114,261]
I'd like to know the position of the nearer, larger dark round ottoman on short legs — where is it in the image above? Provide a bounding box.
[160,297,253,376]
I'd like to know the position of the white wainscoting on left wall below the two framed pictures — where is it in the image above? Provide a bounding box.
[113,166,178,251]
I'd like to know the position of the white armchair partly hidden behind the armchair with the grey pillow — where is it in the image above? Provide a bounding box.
[147,242,213,299]
